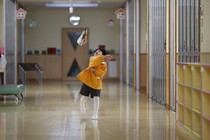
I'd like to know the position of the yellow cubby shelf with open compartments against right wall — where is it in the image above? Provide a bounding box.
[176,63,210,140]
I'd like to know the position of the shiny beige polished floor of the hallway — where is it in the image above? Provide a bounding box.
[0,80,199,140]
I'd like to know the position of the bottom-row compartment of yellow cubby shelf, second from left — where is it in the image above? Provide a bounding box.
[184,108,192,129]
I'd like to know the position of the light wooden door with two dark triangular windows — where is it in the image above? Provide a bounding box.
[62,28,89,80]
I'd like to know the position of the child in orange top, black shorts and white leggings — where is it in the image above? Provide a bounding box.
[77,48,112,120]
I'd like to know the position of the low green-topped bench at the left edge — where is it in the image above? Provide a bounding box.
[0,84,24,101]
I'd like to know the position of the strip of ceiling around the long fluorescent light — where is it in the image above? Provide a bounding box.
[16,0,126,8]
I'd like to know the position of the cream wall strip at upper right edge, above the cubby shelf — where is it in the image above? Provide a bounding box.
[201,0,210,52]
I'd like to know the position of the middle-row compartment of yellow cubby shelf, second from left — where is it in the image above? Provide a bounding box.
[184,87,192,108]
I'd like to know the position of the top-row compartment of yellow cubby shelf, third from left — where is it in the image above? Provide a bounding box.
[192,66,201,89]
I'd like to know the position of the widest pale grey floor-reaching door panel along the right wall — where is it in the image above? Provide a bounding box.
[149,0,166,105]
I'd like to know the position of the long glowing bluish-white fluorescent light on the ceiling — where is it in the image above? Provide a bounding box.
[45,3,98,7]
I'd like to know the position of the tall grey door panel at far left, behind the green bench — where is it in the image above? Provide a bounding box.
[4,0,18,84]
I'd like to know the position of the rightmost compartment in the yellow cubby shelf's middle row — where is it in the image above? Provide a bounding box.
[202,92,210,118]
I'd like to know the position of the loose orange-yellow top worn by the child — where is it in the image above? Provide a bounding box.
[77,55,107,90]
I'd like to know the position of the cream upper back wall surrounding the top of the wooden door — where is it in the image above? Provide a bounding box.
[26,8,119,51]
